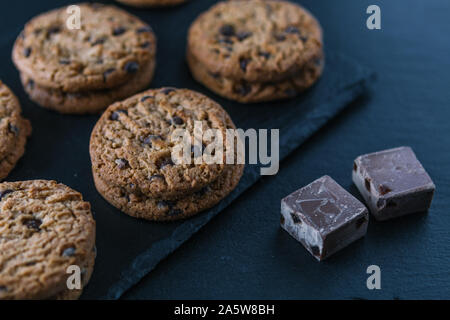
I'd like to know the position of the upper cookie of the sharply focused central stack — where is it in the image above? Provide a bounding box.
[90,88,235,199]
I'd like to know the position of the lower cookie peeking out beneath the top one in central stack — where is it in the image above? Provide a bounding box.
[94,161,244,221]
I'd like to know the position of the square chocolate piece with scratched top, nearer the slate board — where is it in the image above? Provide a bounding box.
[281,176,369,261]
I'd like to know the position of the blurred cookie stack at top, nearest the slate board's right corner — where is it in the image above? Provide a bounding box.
[187,0,324,103]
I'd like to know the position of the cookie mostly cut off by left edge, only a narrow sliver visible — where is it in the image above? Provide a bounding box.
[0,81,31,180]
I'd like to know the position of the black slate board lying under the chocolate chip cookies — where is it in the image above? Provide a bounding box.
[0,1,370,299]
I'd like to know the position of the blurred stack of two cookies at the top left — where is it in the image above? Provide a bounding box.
[12,4,156,114]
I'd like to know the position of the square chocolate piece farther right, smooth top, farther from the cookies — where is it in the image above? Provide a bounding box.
[352,147,435,220]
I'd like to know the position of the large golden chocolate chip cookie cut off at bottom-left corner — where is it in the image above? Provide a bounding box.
[0,180,95,299]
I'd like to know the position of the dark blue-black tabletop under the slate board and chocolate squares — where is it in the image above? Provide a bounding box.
[1,0,450,299]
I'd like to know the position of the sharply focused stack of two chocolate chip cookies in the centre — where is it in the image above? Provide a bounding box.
[90,88,244,221]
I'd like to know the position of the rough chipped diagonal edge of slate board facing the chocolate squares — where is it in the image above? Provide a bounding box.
[100,65,374,300]
